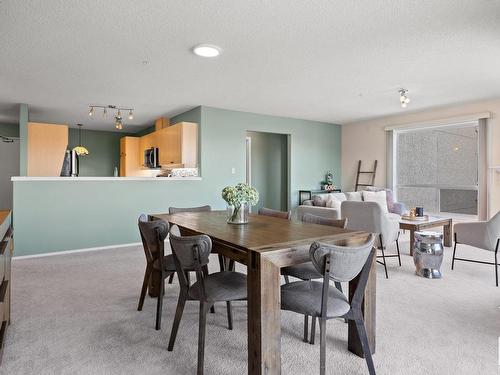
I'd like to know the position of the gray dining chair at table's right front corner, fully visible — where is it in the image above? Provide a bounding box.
[281,234,376,375]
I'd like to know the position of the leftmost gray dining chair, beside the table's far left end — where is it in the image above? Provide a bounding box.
[137,214,175,330]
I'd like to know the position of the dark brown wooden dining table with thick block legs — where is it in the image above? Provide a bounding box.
[150,211,376,375]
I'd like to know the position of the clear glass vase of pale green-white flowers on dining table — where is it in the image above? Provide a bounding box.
[222,183,259,224]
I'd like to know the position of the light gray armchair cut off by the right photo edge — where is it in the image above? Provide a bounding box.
[451,211,500,286]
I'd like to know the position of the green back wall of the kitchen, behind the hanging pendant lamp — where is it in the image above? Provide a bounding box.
[68,128,129,176]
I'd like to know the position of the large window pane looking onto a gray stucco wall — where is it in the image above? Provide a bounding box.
[393,121,478,215]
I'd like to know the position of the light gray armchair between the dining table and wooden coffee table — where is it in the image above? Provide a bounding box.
[340,201,401,278]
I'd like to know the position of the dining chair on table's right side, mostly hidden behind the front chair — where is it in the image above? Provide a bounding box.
[281,213,347,345]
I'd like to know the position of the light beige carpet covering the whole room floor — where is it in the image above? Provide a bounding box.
[0,234,500,375]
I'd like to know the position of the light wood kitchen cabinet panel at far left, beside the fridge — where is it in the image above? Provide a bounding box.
[27,122,68,177]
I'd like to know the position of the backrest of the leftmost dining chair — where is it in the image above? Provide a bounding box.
[138,214,169,263]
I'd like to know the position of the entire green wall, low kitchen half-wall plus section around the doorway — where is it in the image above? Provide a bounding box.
[14,107,341,256]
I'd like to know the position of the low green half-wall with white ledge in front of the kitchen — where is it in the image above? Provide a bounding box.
[12,177,208,256]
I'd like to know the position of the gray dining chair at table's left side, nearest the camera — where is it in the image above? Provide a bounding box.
[168,226,247,375]
